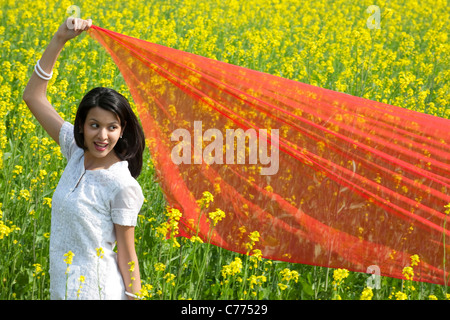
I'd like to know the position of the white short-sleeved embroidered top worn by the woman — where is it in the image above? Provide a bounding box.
[49,122,144,300]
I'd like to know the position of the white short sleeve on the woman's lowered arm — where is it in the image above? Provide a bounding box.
[111,185,144,226]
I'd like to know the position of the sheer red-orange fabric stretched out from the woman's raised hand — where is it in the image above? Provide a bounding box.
[89,26,450,284]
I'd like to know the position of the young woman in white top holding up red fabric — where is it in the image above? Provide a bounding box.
[23,18,145,299]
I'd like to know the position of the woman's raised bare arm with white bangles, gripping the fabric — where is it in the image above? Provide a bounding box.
[22,18,92,144]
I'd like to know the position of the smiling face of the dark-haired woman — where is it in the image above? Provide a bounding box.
[83,107,122,158]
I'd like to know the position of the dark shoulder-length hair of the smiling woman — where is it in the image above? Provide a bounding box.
[74,87,145,178]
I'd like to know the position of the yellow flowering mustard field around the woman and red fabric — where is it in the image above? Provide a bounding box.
[0,0,450,300]
